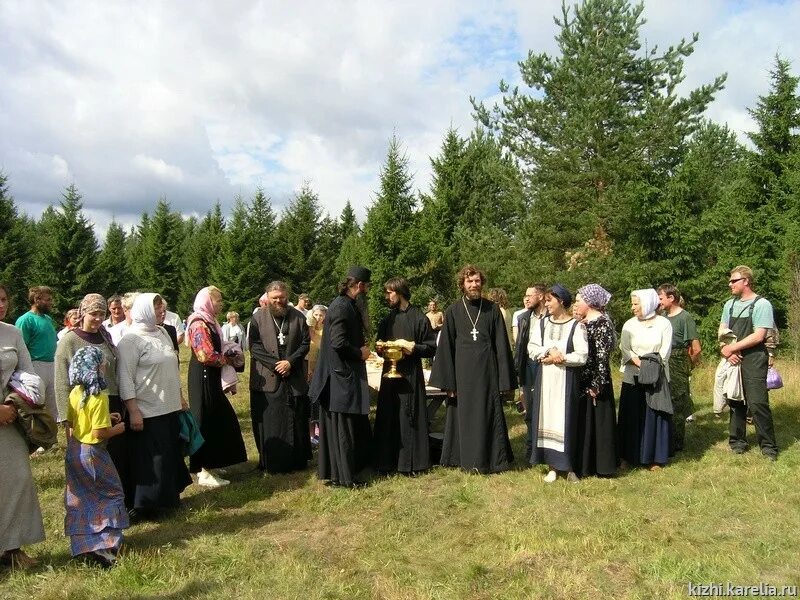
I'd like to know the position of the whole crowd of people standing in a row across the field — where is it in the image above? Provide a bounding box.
[0,265,778,567]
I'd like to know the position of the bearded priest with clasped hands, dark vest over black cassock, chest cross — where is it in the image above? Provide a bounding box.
[249,281,311,473]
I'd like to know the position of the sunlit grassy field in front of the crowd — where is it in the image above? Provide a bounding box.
[0,350,800,600]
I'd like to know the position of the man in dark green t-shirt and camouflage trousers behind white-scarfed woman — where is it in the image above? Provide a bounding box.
[658,283,701,452]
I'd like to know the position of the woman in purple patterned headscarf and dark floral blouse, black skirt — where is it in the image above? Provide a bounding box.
[572,283,617,477]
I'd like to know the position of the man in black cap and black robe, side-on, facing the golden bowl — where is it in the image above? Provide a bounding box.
[309,266,372,487]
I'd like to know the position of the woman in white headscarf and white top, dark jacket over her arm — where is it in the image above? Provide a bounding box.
[617,289,672,471]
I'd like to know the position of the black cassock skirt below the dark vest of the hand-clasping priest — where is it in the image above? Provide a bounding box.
[250,384,311,473]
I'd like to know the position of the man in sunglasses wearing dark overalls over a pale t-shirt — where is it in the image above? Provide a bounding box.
[720,265,778,461]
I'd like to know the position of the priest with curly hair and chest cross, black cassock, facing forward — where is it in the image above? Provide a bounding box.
[430,265,516,473]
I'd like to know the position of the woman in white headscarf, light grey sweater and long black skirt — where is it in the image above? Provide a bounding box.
[117,294,192,517]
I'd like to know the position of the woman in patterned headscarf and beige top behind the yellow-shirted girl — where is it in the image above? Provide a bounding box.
[55,294,132,508]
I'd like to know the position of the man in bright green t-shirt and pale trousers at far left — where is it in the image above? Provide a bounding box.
[14,285,62,422]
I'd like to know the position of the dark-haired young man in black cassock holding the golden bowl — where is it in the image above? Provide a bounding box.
[374,278,436,473]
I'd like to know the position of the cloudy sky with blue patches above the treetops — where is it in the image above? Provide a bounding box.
[0,0,800,235]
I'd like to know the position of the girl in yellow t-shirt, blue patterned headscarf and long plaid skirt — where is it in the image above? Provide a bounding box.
[64,346,128,568]
